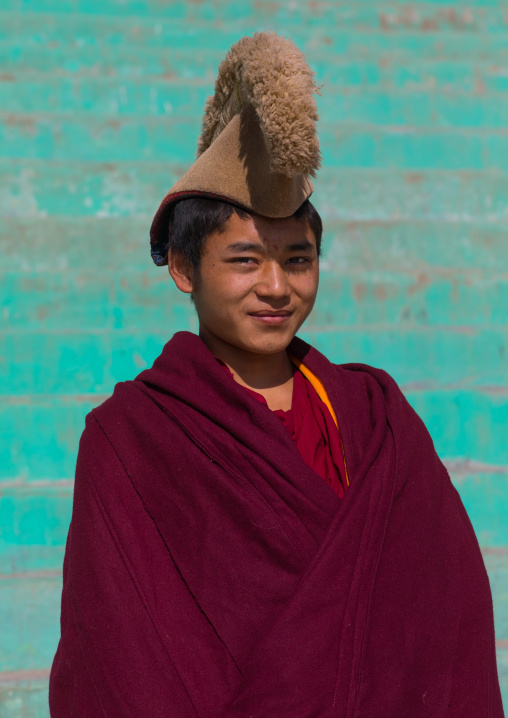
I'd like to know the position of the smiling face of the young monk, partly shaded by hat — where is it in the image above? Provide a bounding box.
[173,213,319,354]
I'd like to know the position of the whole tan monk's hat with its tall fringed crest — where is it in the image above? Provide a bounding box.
[150,32,321,265]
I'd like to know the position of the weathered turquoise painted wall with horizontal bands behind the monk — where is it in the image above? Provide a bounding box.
[0,0,508,718]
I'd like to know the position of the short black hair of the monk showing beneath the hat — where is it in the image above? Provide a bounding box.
[167,197,323,274]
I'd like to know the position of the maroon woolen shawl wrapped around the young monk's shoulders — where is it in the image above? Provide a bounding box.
[50,332,503,718]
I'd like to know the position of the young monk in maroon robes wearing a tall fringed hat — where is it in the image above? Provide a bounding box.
[50,33,503,718]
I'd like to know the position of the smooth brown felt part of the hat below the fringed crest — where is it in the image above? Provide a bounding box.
[150,105,314,264]
